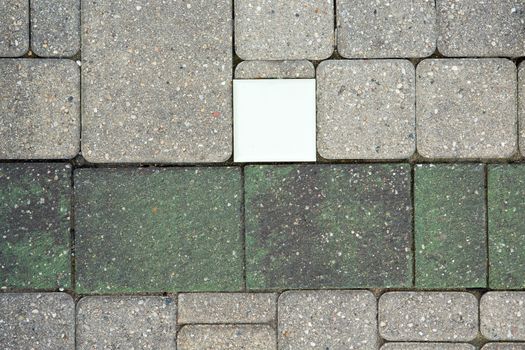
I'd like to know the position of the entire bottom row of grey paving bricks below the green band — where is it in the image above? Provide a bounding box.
[0,290,525,350]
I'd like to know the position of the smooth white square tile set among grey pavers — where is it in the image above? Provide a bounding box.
[233,79,316,162]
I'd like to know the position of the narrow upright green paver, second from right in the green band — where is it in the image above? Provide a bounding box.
[414,164,487,289]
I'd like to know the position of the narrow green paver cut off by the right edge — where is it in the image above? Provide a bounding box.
[488,165,525,289]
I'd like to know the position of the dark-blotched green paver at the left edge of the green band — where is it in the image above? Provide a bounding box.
[0,163,72,290]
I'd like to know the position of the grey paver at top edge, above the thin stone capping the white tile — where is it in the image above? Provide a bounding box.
[234,0,334,60]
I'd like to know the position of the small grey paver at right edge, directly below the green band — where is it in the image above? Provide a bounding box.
[480,292,525,341]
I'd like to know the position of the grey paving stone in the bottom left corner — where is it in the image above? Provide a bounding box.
[0,293,75,350]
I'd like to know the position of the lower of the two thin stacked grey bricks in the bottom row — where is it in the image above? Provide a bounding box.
[177,325,277,350]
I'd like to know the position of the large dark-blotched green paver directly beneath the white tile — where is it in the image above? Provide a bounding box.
[245,164,412,290]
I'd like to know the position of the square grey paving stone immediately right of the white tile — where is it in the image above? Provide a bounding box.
[317,60,416,159]
